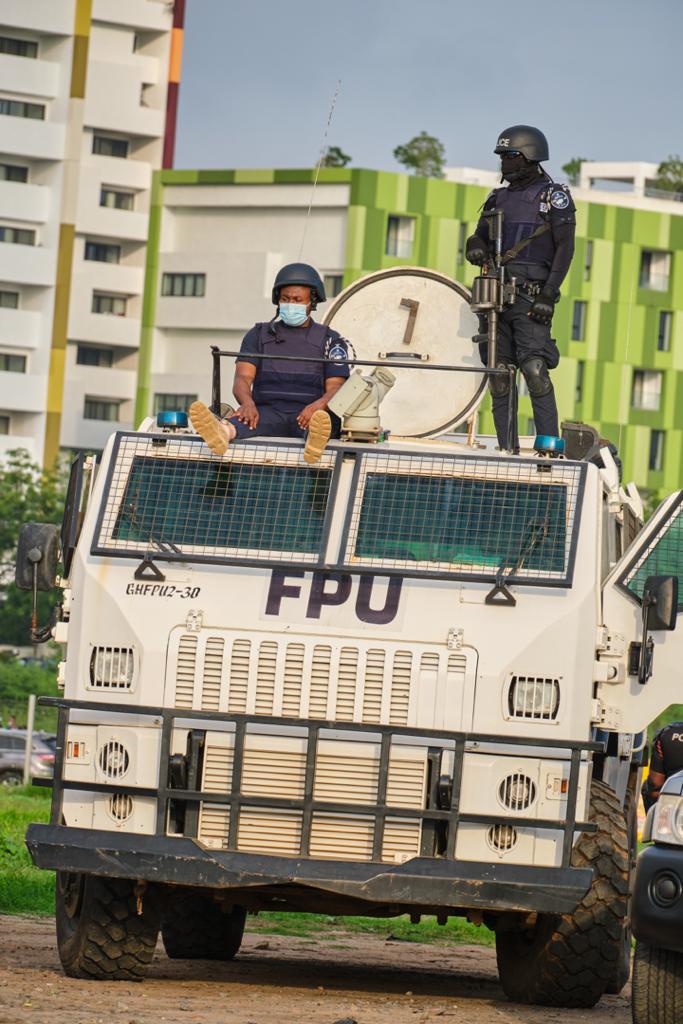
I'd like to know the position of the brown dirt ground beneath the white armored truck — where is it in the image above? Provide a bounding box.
[0,916,631,1024]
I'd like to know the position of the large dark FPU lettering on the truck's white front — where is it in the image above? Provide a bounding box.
[265,569,403,626]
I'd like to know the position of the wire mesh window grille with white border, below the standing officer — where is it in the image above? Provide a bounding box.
[343,455,585,583]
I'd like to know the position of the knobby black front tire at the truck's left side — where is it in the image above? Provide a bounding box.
[55,871,160,981]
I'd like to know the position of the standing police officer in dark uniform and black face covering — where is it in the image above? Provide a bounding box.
[466,125,577,449]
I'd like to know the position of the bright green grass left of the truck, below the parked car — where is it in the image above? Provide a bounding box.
[0,785,54,914]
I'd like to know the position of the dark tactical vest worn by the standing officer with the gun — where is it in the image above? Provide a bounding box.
[496,178,555,281]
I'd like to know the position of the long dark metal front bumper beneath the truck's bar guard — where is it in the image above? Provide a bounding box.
[27,824,593,913]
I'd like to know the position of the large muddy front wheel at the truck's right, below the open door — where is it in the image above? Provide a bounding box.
[496,781,629,1008]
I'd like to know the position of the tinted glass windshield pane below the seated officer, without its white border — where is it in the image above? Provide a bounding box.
[105,456,332,555]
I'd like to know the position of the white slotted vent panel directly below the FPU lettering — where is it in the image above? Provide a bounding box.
[169,631,467,728]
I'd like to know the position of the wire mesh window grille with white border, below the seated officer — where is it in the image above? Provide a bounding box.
[95,434,335,564]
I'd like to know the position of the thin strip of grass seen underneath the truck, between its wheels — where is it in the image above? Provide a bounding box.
[249,911,496,946]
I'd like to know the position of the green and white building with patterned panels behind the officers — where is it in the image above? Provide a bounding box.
[136,164,683,501]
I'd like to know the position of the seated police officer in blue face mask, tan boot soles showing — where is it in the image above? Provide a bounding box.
[189,263,349,462]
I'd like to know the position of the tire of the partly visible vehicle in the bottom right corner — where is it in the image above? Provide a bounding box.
[631,942,683,1024]
